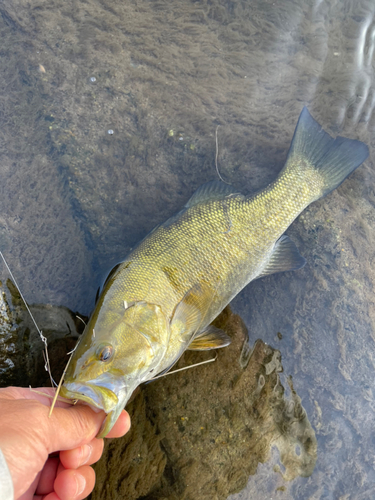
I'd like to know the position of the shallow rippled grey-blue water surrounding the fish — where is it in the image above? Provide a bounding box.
[0,0,375,500]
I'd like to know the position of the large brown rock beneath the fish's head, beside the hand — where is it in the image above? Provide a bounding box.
[91,307,317,500]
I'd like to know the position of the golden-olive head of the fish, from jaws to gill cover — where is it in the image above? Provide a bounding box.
[61,302,169,437]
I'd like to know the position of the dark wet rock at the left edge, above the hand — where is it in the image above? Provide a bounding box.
[0,279,83,387]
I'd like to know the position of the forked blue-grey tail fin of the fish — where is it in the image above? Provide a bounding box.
[284,108,369,199]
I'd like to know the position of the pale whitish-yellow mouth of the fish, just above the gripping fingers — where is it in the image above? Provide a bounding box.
[60,373,127,413]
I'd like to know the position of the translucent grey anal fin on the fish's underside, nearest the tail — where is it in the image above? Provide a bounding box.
[258,235,306,278]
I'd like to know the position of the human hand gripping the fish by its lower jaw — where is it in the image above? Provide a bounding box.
[0,387,130,500]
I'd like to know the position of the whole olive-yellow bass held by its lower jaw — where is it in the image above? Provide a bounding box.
[61,108,369,437]
